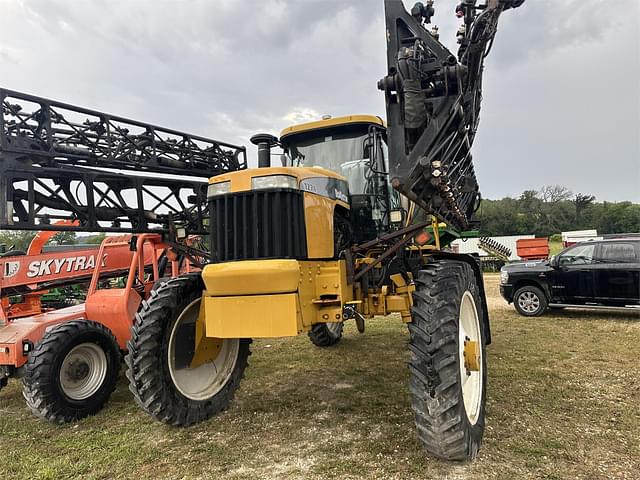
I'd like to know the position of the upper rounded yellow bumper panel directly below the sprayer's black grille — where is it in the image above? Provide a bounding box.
[202,260,300,297]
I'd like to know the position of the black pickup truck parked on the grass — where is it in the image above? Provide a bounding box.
[500,237,640,317]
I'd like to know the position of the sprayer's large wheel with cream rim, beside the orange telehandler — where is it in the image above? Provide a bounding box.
[126,274,251,426]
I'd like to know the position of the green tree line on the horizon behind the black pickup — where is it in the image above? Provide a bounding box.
[478,185,640,237]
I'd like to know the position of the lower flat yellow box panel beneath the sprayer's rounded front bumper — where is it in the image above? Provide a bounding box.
[204,293,303,338]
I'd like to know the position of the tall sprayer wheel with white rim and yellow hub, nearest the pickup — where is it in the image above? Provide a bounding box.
[409,260,487,461]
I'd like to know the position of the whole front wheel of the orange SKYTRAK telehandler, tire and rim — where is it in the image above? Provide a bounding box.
[22,320,120,423]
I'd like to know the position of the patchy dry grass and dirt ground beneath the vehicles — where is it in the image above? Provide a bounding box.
[0,275,640,480]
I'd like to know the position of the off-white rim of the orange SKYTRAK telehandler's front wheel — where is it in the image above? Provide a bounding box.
[60,343,108,401]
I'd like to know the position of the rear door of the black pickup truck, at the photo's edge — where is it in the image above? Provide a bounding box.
[594,241,640,305]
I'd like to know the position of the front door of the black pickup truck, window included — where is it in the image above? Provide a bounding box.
[551,244,595,304]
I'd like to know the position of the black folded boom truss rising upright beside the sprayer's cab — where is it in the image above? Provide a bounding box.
[378,0,524,230]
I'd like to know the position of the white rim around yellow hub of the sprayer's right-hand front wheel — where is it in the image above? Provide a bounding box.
[458,290,484,425]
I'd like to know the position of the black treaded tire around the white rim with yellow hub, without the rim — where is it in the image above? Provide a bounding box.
[409,260,486,461]
